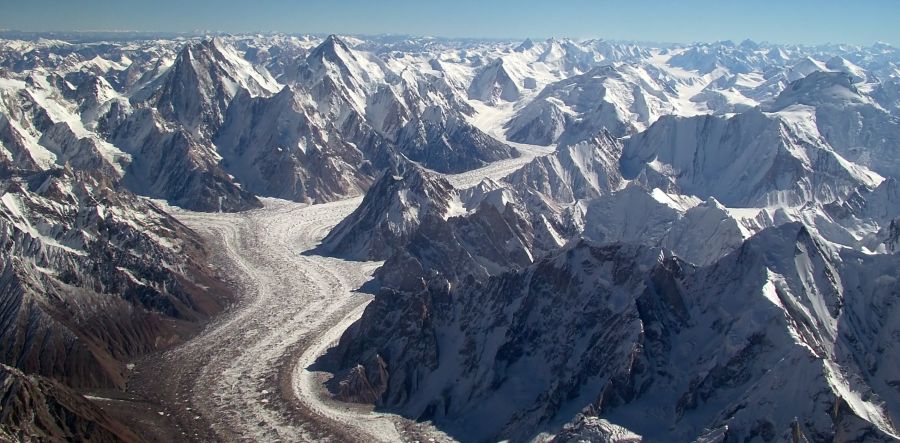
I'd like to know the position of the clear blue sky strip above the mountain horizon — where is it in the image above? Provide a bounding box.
[0,0,900,46]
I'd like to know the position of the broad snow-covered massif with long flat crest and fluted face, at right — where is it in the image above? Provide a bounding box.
[621,110,878,207]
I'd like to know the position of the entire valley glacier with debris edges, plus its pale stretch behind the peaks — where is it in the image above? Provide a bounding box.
[106,150,542,442]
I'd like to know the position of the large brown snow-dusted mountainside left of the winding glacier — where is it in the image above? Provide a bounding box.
[0,170,226,387]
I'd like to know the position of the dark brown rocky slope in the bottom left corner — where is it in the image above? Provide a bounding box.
[0,365,140,442]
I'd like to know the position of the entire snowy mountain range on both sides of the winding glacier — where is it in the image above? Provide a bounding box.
[0,32,900,443]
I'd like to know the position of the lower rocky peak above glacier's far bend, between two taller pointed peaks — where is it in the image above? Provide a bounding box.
[216,87,374,203]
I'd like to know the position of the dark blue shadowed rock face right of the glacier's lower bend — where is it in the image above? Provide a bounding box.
[326,244,680,440]
